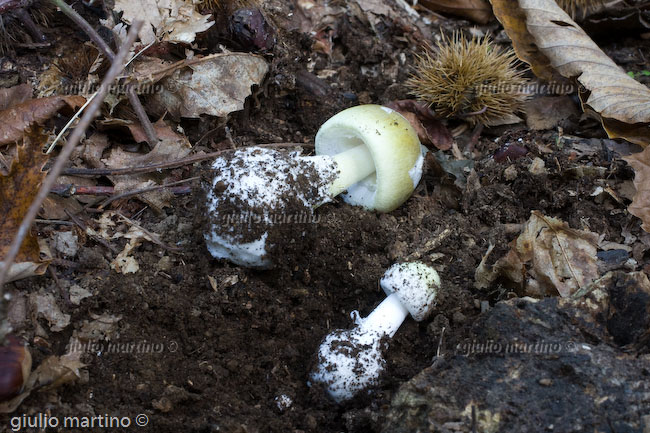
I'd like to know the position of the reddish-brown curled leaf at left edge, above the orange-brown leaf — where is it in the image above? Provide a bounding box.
[0,96,86,146]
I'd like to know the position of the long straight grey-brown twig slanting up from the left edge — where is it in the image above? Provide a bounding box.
[0,21,142,290]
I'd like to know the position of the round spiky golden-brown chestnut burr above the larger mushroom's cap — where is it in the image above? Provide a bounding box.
[406,33,527,126]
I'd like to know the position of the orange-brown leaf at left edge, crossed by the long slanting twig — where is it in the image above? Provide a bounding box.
[0,129,49,281]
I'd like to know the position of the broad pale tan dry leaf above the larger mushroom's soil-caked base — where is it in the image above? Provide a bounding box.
[149,53,269,118]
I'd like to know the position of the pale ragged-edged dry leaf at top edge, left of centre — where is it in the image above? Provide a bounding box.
[113,0,214,45]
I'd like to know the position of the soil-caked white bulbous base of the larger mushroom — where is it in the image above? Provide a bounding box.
[204,147,336,269]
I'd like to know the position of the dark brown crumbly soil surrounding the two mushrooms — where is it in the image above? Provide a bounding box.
[0,2,649,433]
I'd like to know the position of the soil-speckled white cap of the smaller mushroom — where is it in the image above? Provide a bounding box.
[379,262,440,322]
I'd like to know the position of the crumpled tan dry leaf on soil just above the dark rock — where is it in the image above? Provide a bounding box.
[475,211,598,297]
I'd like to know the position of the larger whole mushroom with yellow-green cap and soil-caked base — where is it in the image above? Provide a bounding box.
[204,105,424,269]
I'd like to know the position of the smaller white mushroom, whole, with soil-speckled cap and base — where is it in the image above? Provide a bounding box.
[308,262,440,403]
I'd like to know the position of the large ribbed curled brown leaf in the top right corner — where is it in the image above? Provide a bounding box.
[492,0,650,146]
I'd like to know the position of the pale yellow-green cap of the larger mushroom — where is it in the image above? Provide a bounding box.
[315,105,424,212]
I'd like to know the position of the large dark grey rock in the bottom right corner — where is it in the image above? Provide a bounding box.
[382,272,650,433]
